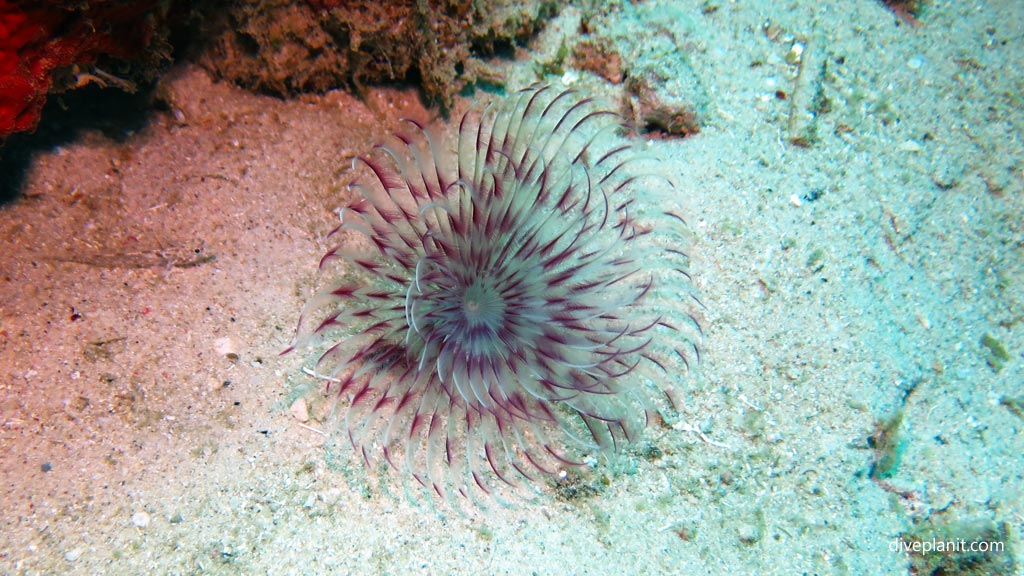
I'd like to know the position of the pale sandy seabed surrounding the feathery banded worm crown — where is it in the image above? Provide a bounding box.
[0,0,1024,575]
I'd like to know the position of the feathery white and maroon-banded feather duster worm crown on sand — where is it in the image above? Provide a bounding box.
[289,86,699,497]
